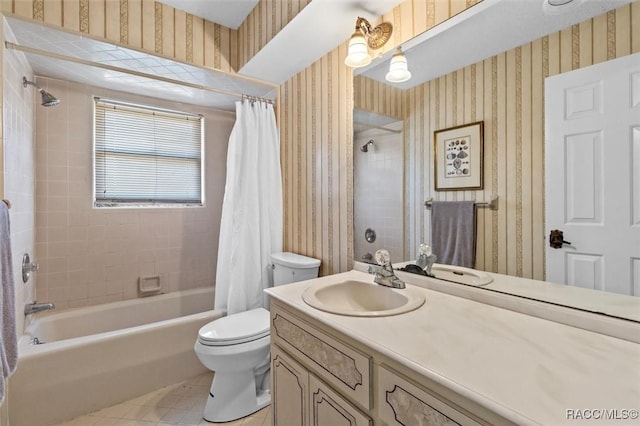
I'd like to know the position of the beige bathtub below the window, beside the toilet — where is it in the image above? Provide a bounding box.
[8,288,223,426]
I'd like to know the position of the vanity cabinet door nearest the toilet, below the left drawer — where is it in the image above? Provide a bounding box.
[271,345,309,426]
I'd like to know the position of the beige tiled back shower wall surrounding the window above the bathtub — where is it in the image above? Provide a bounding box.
[36,78,235,308]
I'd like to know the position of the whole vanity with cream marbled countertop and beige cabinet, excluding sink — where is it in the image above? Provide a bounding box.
[267,271,640,426]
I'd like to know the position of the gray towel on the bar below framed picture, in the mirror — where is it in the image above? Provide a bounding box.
[431,201,476,268]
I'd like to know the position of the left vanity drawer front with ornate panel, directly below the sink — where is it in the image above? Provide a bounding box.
[271,310,371,411]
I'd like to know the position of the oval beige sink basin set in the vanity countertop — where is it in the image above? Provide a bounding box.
[302,280,425,317]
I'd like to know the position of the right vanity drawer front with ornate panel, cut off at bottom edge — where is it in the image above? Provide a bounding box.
[376,366,480,426]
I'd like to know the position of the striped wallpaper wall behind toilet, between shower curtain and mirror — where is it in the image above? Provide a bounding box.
[280,44,353,275]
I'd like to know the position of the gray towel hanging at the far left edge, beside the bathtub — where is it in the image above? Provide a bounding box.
[0,202,18,404]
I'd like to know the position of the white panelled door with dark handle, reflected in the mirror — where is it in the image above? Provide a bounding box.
[545,54,640,296]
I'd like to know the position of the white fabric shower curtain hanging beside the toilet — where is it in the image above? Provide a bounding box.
[215,100,283,315]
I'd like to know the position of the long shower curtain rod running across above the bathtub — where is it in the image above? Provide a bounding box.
[4,41,275,104]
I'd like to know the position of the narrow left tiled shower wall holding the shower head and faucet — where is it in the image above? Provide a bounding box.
[2,28,34,333]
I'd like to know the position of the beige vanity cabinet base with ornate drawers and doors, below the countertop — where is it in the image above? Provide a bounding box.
[271,300,510,426]
